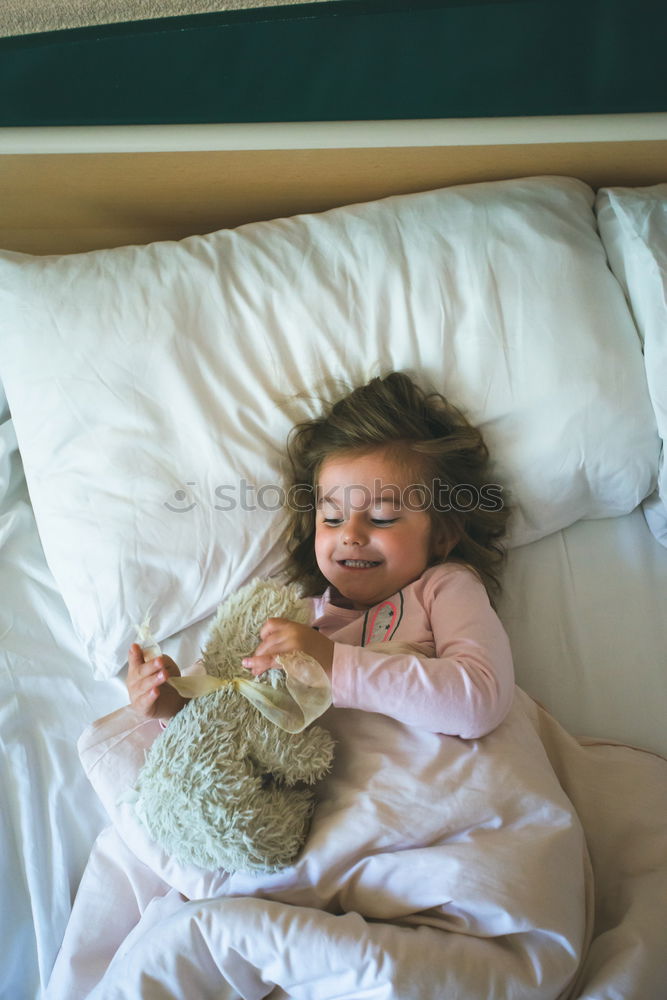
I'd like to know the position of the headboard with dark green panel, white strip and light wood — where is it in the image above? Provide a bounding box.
[0,0,667,253]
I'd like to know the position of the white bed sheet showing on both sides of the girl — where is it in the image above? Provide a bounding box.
[0,408,667,1000]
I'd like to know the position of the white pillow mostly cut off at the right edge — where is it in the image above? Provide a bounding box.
[596,184,667,546]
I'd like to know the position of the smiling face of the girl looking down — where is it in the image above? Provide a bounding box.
[315,450,440,609]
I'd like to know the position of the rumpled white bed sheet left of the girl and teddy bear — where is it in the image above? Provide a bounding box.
[0,421,125,1000]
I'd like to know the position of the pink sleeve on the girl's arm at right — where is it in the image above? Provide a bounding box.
[332,570,514,739]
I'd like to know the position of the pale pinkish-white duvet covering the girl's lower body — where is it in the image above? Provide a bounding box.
[47,690,667,1000]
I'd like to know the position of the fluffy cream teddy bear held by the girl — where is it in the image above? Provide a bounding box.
[136,580,333,872]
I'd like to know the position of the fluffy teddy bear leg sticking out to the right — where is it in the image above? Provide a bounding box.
[253,723,334,785]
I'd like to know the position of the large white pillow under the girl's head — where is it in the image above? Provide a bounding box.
[0,178,659,676]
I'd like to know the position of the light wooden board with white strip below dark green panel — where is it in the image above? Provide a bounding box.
[0,113,667,253]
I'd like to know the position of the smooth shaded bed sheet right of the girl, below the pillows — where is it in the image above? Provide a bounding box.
[498,507,667,755]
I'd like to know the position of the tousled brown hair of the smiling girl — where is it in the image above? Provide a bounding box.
[286,372,509,595]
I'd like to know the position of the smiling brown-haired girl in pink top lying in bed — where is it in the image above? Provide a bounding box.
[128,372,514,739]
